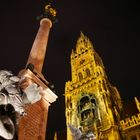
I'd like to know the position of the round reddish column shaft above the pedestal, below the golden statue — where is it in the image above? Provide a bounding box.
[27,18,52,72]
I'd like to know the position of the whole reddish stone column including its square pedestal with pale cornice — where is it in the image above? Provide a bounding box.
[18,6,57,140]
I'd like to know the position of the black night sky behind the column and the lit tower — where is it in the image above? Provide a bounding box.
[0,0,140,138]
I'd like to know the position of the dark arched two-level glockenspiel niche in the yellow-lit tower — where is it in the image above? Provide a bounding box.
[77,94,97,126]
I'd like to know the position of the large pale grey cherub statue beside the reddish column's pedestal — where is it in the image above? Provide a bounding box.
[0,70,42,140]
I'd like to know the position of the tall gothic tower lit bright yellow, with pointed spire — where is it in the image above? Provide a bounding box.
[65,33,122,140]
